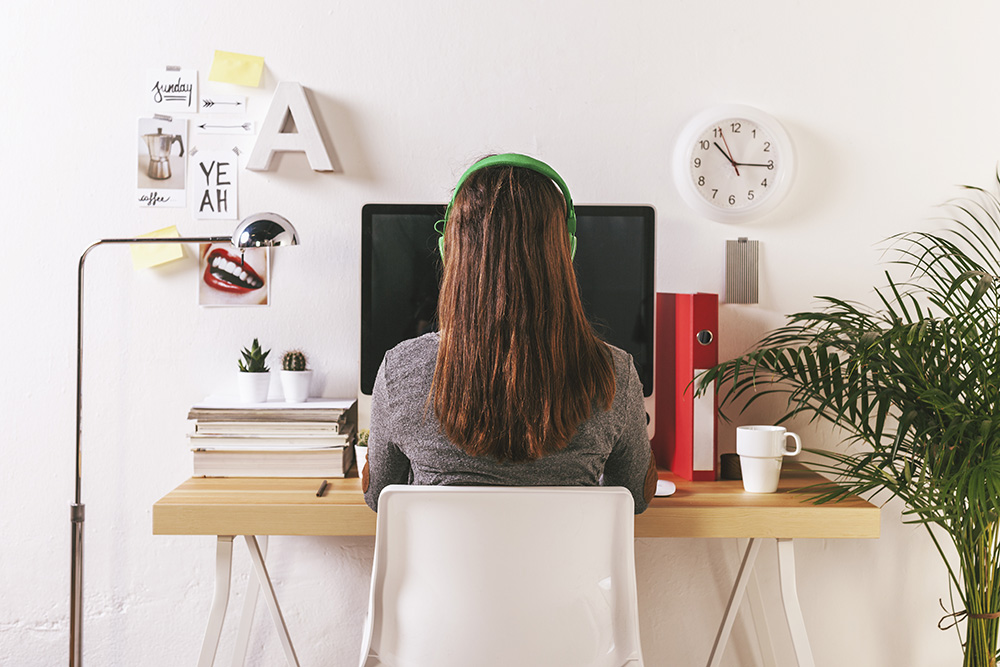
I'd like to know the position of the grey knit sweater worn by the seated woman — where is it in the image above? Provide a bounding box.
[365,332,650,514]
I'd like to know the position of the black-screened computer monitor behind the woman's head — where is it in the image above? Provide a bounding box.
[358,204,656,435]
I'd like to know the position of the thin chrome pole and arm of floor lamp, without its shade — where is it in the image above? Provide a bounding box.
[69,236,232,667]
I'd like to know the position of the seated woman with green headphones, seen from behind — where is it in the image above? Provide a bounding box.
[362,155,656,513]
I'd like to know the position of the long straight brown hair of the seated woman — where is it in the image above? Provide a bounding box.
[433,166,615,462]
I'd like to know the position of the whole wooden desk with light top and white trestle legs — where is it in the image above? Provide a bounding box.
[153,462,879,667]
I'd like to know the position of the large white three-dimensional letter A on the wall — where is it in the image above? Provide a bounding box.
[247,81,334,171]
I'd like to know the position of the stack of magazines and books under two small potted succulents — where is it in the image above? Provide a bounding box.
[188,398,357,477]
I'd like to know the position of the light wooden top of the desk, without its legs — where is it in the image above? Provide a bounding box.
[153,463,879,538]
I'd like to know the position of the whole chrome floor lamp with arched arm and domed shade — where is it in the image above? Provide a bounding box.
[69,213,299,667]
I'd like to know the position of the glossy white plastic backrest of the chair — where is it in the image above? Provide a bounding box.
[361,485,642,667]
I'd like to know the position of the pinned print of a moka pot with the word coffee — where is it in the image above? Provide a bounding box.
[136,117,187,208]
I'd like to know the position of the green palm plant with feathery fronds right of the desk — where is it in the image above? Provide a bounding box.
[697,177,1000,667]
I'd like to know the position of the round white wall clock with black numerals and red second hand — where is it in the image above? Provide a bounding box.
[674,104,795,222]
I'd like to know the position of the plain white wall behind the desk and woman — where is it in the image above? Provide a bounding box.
[0,0,1000,667]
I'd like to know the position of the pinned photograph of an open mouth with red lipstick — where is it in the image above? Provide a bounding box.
[198,243,271,306]
